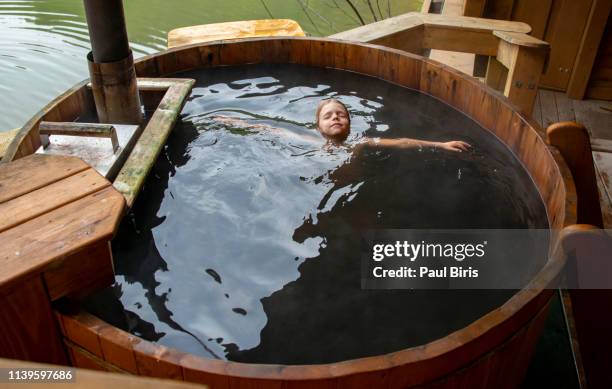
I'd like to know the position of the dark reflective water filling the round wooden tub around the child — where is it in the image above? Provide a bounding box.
[83,66,547,364]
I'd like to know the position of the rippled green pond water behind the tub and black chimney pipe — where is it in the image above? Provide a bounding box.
[0,0,422,131]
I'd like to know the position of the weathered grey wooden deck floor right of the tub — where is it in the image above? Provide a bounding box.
[532,89,612,228]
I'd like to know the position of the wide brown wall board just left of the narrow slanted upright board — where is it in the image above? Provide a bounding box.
[541,0,592,90]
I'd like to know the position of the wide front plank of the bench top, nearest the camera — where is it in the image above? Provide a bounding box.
[0,187,125,286]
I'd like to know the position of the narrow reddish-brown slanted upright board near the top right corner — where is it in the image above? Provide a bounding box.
[567,0,612,99]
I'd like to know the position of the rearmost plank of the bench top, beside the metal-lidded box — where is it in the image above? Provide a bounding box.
[0,155,89,203]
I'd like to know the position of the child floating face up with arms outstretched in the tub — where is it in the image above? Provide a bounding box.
[213,98,471,152]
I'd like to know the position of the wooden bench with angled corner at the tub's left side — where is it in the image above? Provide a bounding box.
[0,155,125,364]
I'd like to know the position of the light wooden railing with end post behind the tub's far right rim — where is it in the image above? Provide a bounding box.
[331,12,548,114]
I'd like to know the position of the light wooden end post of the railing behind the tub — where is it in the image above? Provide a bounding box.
[493,31,548,115]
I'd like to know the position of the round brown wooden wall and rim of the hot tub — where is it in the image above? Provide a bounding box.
[2,38,575,388]
